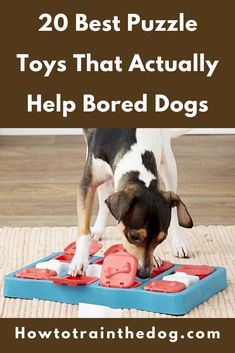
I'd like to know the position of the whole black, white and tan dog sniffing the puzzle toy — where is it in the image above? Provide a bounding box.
[69,128,193,278]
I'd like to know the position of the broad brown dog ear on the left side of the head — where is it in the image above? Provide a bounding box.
[105,188,135,223]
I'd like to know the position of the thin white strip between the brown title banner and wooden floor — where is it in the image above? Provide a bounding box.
[0,128,235,136]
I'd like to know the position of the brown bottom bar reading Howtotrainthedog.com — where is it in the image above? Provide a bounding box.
[0,318,232,353]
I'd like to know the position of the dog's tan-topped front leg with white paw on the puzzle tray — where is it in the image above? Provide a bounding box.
[69,180,97,276]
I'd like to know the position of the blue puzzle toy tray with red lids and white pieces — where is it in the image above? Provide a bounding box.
[4,241,227,315]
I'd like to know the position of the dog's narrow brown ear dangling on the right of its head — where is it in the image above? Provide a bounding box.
[164,191,193,228]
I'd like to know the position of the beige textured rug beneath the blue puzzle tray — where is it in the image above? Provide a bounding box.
[0,226,235,318]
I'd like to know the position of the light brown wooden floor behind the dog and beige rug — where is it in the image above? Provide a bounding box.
[0,135,235,227]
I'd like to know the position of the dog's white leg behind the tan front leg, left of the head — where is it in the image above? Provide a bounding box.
[91,180,114,240]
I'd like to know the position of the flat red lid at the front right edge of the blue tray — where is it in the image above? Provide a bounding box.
[144,280,186,293]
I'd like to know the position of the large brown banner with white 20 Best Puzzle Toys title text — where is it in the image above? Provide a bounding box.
[0,0,234,128]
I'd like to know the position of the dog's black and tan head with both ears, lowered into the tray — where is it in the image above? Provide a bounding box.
[105,185,193,278]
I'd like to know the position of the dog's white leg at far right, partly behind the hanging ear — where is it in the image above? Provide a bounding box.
[159,131,190,258]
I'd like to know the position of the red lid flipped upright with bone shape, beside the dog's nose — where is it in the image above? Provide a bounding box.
[100,252,138,288]
